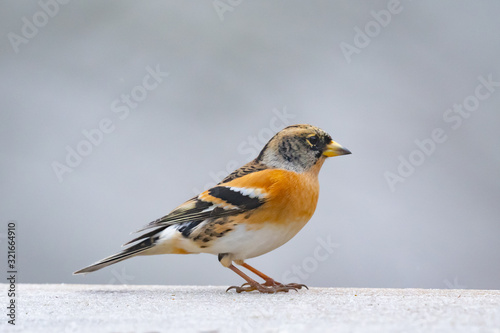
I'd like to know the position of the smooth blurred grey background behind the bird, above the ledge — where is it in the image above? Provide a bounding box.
[0,0,500,289]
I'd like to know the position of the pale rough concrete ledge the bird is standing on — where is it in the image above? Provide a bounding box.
[0,284,500,333]
